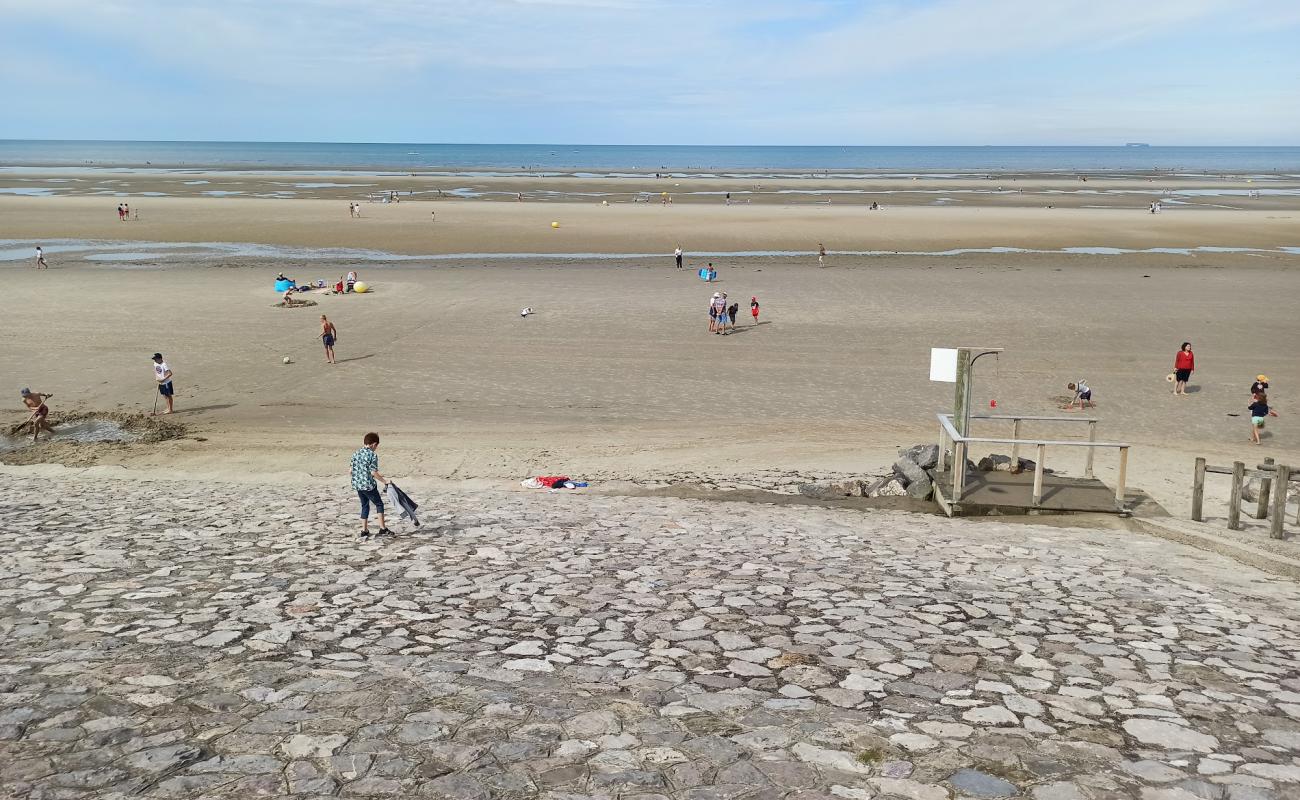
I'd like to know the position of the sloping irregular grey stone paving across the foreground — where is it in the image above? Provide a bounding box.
[0,471,1300,800]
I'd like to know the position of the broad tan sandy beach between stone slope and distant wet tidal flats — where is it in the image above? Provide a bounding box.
[0,189,1300,513]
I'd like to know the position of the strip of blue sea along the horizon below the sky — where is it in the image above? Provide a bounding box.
[0,139,1300,174]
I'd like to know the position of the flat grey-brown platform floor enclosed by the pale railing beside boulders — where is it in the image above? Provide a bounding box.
[935,471,1145,516]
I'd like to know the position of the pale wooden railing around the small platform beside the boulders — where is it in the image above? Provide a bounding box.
[937,414,1128,509]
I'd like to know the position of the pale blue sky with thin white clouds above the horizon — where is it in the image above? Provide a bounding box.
[0,0,1300,146]
